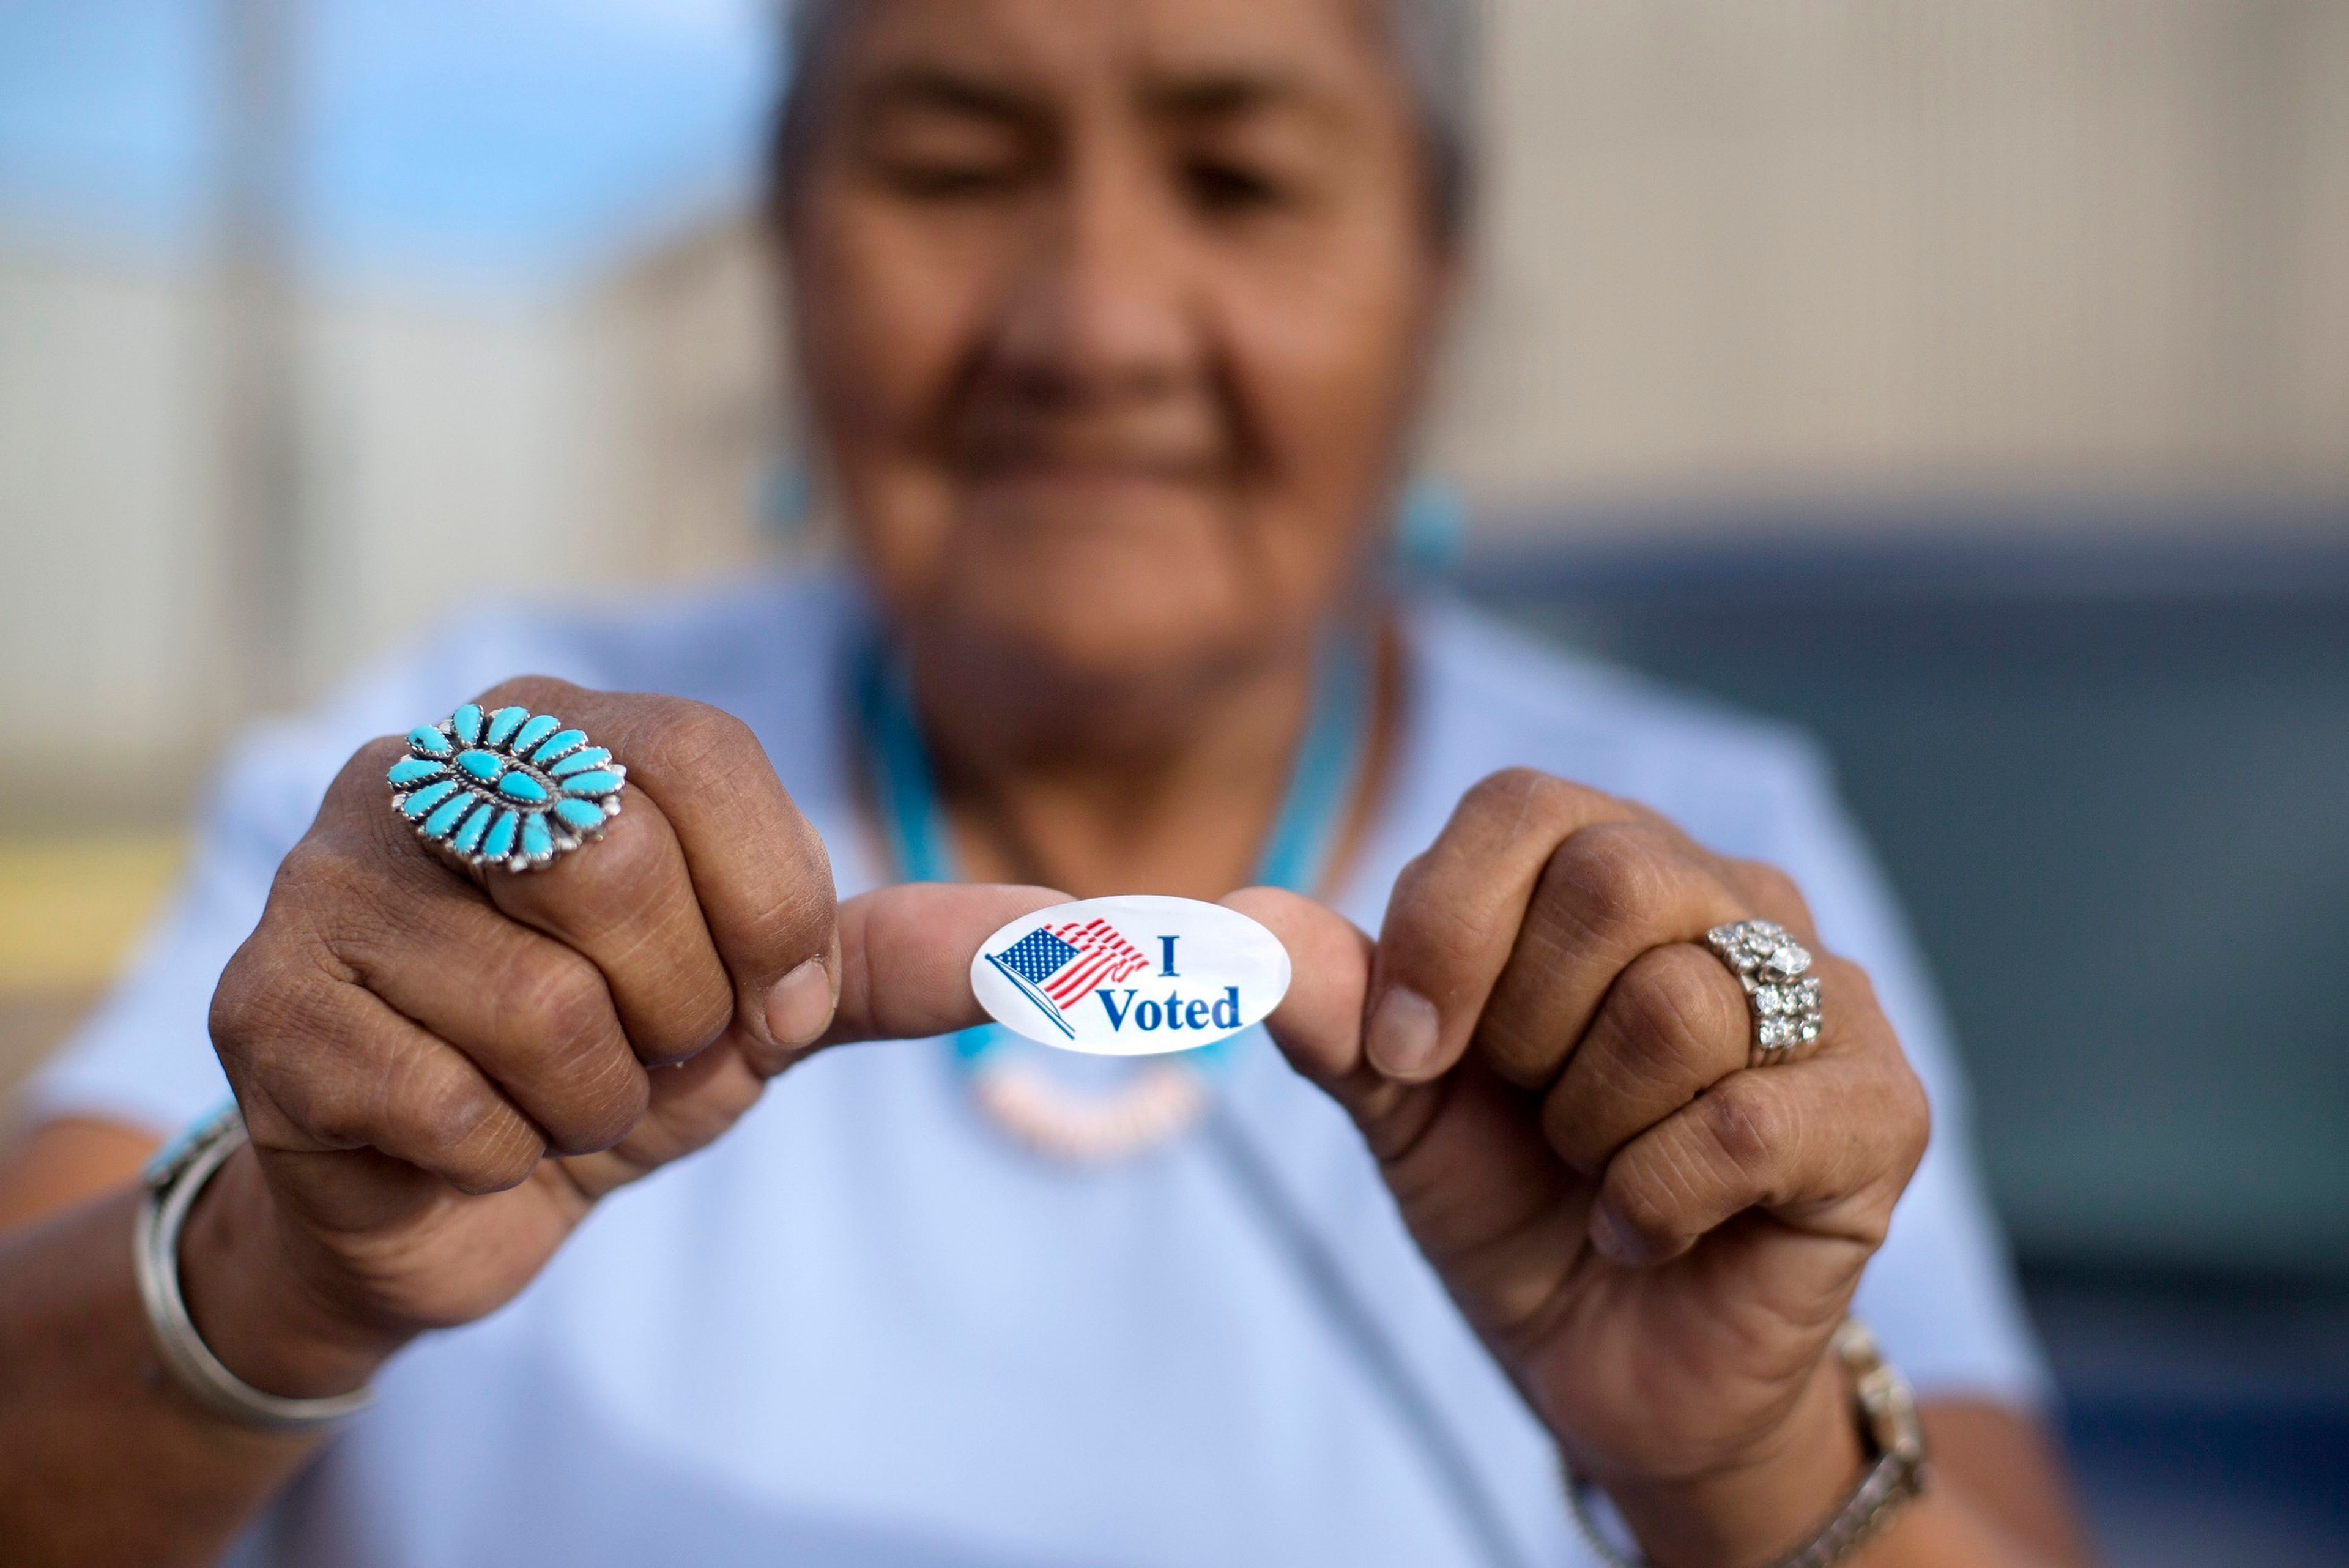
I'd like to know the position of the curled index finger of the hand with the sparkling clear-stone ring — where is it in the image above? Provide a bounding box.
[1365,769,1642,1082]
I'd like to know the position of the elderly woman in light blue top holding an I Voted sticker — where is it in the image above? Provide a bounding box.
[0,0,2077,1568]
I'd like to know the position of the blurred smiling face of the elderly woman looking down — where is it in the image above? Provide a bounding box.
[785,0,1447,700]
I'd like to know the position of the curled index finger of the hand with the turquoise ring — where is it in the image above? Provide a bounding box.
[484,677,839,1053]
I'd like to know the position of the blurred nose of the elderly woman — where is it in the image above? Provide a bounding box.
[996,141,1203,407]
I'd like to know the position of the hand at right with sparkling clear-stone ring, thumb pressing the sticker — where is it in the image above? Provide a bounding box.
[1231,769,1926,1563]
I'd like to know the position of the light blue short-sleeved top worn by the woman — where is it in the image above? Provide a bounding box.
[26,576,2046,1568]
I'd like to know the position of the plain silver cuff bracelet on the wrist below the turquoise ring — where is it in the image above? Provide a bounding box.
[132,1100,376,1432]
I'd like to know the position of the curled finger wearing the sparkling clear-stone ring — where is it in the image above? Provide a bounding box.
[1541,943,1753,1175]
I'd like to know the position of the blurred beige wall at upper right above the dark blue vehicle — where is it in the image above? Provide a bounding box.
[1435,0,2349,517]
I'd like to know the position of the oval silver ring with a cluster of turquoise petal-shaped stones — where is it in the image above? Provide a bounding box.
[385,703,627,872]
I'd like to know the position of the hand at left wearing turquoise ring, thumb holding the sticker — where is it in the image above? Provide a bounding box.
[181,680,1057,1396]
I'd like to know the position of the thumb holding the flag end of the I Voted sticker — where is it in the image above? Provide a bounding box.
[817,882,1069,1046]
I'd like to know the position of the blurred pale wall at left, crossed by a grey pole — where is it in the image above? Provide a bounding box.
[0,251,660,832]
